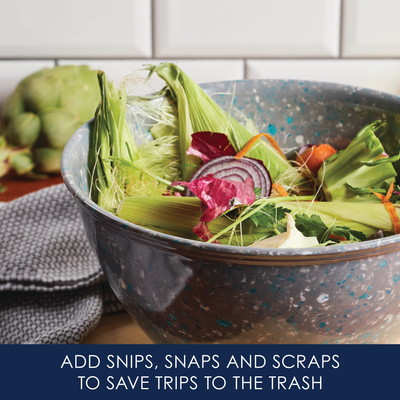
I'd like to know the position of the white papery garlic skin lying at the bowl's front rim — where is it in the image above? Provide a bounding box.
[248,213,319,249]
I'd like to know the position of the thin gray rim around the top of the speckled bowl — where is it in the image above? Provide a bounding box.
[61,79,400,264]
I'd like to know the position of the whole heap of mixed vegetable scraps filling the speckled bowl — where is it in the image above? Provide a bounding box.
[88,63,400,248]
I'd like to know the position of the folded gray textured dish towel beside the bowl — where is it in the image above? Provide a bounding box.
[0,184,123,344]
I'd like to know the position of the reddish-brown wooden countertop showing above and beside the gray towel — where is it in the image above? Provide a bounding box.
[0,176,152,344]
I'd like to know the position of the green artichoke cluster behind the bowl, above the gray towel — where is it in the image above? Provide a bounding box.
[0,65,100,178]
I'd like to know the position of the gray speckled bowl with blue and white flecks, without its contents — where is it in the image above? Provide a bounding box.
[62,80,400,343]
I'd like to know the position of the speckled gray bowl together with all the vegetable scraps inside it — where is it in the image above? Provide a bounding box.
[62,63,400,343]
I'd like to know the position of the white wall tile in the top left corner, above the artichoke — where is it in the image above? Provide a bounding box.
[0,0,151,58]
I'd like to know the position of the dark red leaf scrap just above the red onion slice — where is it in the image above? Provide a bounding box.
[186,132,236,163]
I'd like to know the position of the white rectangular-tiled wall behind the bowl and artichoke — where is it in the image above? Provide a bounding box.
[0,0,400,105]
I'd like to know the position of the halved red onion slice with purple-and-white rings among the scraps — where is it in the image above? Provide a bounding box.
[186,156,272,197]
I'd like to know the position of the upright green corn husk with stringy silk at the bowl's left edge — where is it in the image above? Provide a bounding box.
[88,71,183,212]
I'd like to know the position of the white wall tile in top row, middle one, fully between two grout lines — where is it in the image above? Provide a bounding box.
[154,0,340,58]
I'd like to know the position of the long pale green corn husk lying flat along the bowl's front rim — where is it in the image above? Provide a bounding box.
[117,196,400,247]
